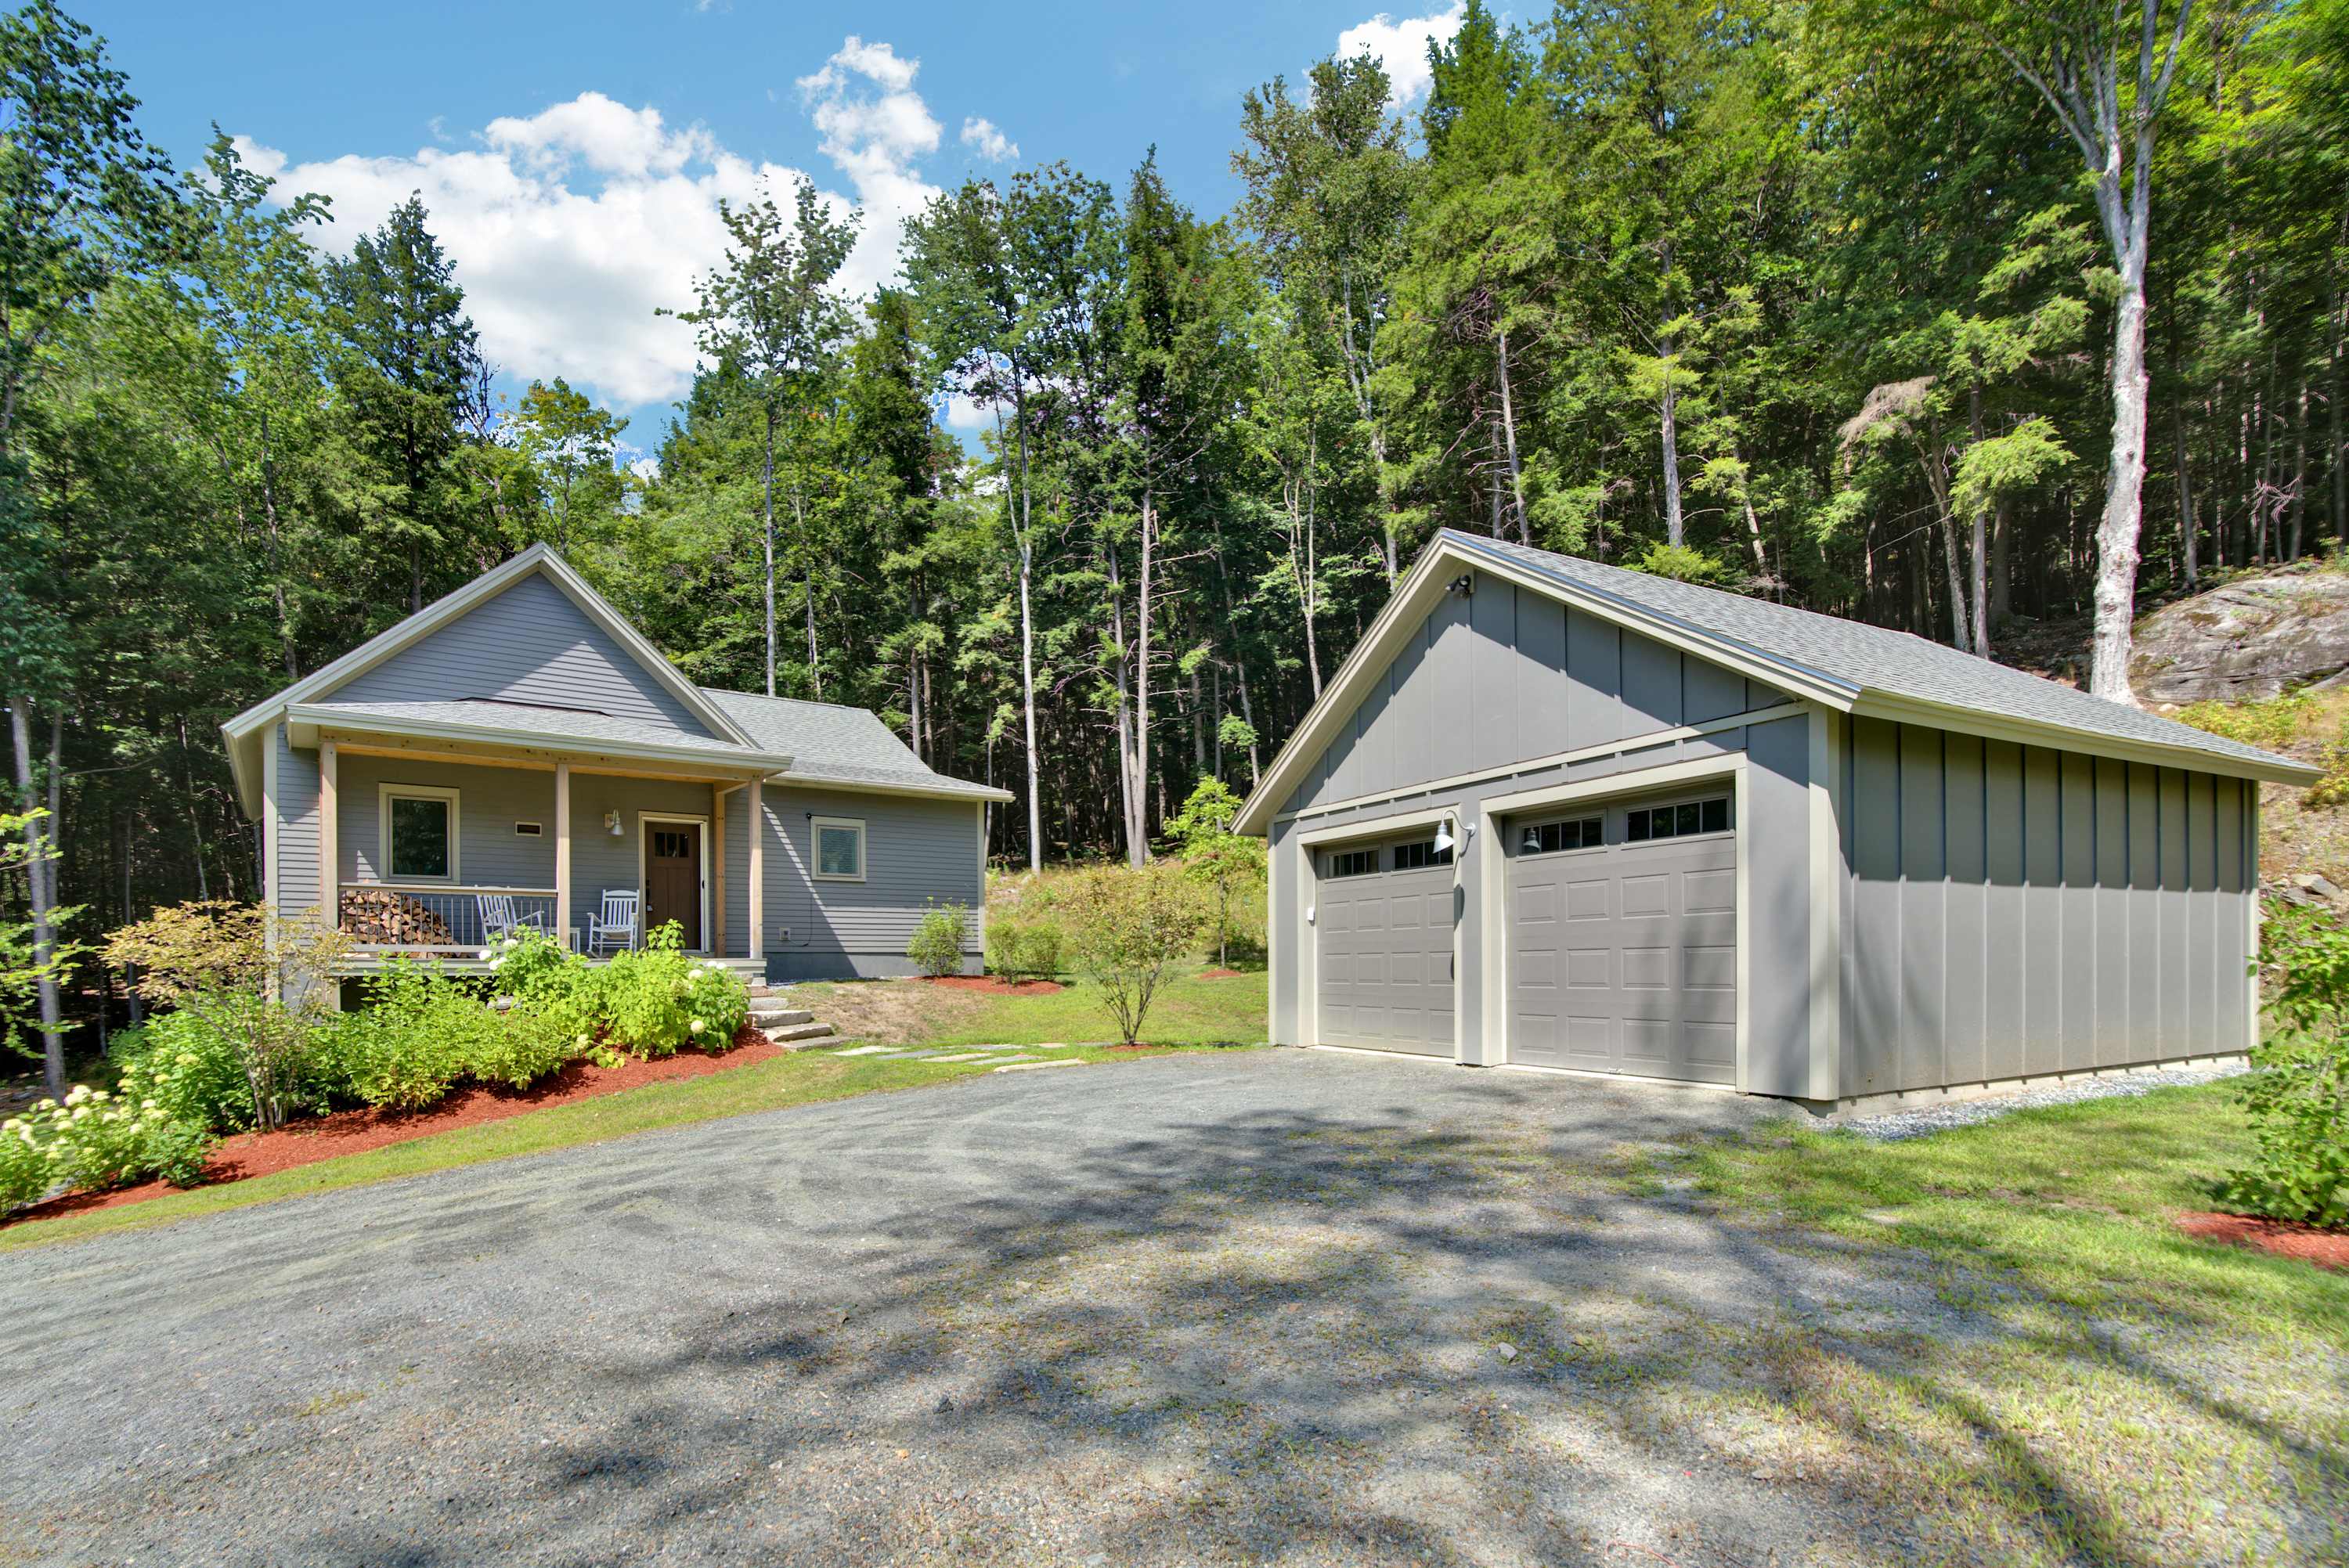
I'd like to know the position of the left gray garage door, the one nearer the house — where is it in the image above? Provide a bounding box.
[1313,833,1452,1056]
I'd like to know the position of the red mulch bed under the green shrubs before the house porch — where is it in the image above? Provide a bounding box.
[7,1023,785,1225]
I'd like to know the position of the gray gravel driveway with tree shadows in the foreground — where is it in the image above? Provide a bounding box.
[0,1051,2321,1566]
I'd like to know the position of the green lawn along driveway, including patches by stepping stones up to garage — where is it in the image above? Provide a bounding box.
[0,974,1264,1251]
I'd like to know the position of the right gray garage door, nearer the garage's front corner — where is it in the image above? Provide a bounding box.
[1503,793,1738,1084]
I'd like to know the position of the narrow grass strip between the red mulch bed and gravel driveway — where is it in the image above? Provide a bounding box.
[0,1028,1261,1251]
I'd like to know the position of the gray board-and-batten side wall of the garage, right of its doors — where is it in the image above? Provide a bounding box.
[1842,719,2257,1096]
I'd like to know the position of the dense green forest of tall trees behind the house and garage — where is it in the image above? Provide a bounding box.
[0,0,2349,1051]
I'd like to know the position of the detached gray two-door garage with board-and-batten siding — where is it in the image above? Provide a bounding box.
[1240,531,2316,1105]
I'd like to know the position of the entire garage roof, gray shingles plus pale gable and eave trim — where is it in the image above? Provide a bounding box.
[1236,528,2318,833]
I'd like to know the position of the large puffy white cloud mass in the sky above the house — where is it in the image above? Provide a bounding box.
[237,38,963,406]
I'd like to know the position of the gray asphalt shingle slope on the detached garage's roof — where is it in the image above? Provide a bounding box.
[1442,528,2300,768]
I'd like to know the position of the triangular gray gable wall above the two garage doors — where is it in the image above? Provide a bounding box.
[1280,571,1792,812]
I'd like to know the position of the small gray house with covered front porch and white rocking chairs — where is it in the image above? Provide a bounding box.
[223,545,1010,981]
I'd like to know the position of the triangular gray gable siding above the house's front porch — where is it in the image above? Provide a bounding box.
[334,573,714,740]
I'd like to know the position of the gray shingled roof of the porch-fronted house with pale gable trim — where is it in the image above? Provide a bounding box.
[221,545,1010,816]
